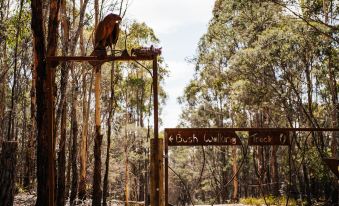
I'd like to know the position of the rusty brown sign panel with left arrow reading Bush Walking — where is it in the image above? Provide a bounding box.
[165,128,241,146]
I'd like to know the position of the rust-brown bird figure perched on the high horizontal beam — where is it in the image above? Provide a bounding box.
[91,14,122,56]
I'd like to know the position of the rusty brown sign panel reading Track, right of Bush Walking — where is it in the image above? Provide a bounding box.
[248,130,290,145]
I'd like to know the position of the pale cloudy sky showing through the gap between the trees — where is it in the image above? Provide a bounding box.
[126,0,214,129]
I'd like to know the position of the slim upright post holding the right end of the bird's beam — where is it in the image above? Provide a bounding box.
[151,55,160,206]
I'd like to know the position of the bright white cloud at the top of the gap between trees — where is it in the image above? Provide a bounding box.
[127,0,214,33]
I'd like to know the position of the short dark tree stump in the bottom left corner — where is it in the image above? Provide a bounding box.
[0,141,18,206]
